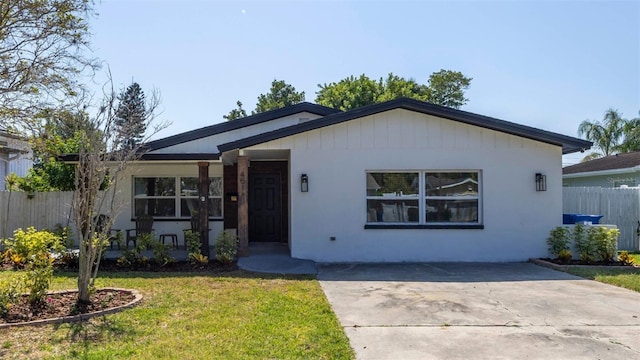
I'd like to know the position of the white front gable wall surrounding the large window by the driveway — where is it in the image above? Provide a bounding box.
[250,109,562,262]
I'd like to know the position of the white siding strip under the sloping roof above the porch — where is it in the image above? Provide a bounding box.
[151,112,320,154]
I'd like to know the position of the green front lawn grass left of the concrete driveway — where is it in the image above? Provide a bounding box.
[0,271,354,359]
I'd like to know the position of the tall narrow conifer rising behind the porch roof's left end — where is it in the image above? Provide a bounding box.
[115,82,147,149]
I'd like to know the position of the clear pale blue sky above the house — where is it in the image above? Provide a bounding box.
[90,0,640,166]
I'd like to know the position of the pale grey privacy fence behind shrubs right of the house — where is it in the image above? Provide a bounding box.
[562,187,640,250]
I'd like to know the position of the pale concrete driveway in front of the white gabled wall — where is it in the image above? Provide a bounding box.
[318,263,640,359]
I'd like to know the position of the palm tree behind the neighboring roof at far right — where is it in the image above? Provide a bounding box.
[578,109,628,157]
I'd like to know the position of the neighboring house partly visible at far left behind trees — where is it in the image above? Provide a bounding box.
[0,128,33,191]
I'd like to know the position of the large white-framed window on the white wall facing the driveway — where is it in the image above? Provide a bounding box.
[366,171,480,225]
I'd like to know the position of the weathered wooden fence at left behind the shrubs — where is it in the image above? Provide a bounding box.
[0,191,73,238]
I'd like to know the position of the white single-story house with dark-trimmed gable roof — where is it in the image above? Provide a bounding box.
[95,99,591,262]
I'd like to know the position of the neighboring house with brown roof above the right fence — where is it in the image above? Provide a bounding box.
[562,152,640,187]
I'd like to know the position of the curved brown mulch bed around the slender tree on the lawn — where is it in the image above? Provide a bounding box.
[0,289,135,324]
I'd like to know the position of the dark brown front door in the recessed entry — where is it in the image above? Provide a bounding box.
[249,173,282,242]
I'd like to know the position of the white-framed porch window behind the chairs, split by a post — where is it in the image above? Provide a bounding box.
[133,177,222,218]
